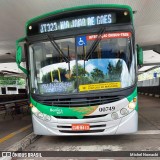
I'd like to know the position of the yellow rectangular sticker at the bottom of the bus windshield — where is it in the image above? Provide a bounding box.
[79,82,121,92]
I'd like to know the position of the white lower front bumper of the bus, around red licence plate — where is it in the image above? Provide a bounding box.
[32,110,138,136]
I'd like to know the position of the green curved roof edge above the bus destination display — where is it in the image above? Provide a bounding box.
[25,4,133,35]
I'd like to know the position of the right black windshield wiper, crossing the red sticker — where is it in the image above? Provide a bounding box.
[85,27,106,60]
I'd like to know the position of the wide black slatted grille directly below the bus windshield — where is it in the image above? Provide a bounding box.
[39,96,124,107]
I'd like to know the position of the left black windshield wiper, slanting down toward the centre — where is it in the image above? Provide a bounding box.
[47,34,69,63]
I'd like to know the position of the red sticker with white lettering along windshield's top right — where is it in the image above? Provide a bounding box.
[87,32,131,41]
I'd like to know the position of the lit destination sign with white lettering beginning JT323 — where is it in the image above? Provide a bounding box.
[39,13,116,33]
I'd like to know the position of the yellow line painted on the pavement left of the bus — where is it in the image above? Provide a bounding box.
[0,124,32,143]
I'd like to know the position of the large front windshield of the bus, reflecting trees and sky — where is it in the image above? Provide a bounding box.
[29,32,136,94]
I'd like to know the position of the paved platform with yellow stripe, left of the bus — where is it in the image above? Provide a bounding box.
[0,114,33,151]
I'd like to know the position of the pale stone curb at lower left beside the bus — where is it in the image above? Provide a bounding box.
[5,132,41,152]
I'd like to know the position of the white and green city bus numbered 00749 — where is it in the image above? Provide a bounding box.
[16,4,143,135]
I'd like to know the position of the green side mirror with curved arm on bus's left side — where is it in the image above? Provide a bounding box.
[16,38,28,74]
